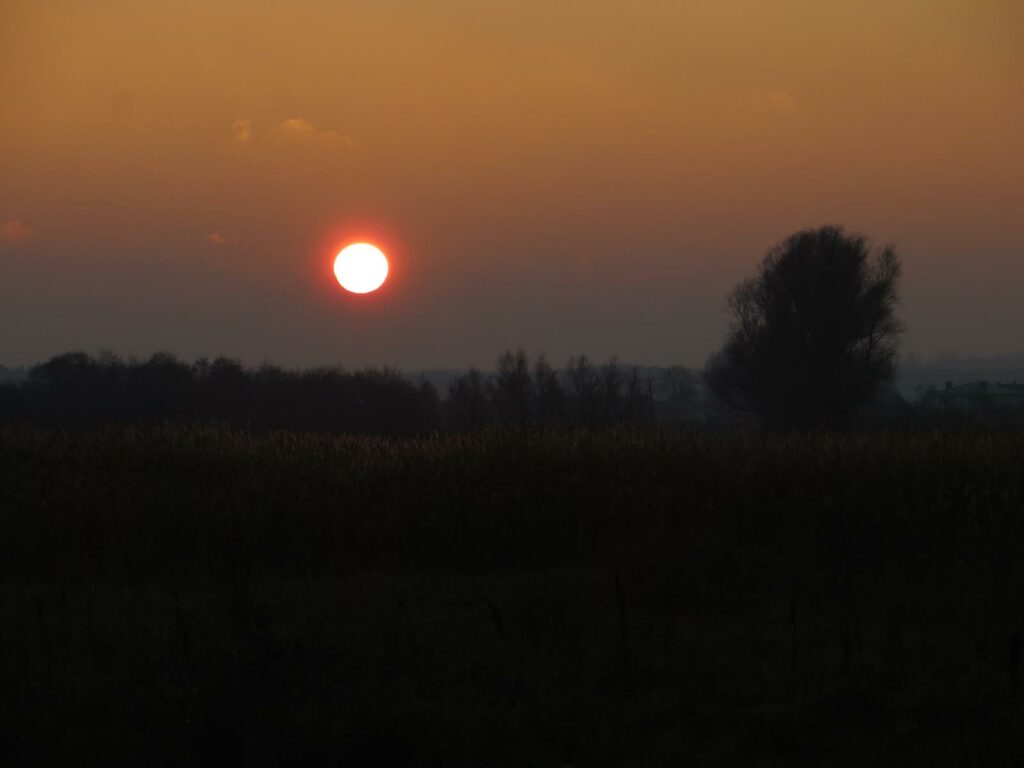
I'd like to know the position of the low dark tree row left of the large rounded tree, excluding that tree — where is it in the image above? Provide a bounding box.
[0,349,698,434]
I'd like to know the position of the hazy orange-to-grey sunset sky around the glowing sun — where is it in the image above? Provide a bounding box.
[0,0,1024,370]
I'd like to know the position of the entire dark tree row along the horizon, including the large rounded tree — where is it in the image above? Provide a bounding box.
[8,226,1015,434]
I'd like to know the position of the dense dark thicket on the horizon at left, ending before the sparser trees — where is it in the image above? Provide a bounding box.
[0,353,440,434]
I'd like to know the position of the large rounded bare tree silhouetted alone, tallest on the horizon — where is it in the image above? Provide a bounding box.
[706,226,903,427]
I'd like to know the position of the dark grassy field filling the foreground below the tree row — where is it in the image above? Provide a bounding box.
[0,428,1024,766]
